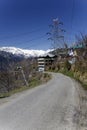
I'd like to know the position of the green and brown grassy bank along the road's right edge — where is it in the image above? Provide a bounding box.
[49,60,87,90]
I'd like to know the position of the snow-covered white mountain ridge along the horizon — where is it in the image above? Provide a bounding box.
[0,47,52,58]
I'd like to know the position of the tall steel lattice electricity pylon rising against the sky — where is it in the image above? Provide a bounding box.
[47,18,65,53]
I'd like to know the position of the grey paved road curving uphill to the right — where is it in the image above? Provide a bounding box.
[0,73,79,130]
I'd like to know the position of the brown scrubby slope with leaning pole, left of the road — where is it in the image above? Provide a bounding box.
[0,59,51,98]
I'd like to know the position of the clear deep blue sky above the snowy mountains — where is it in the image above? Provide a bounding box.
[0,0,87,50]
